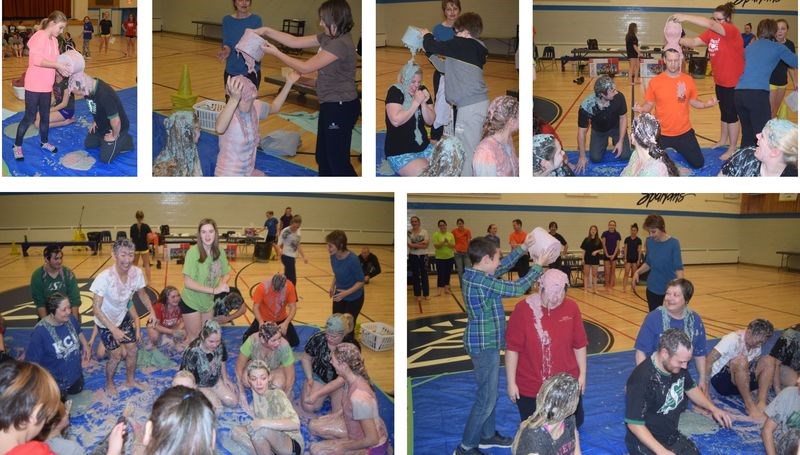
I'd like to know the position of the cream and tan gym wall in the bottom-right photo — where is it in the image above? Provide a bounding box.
[408,193,800,267]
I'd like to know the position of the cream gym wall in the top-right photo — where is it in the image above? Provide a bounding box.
[533,0,797,57]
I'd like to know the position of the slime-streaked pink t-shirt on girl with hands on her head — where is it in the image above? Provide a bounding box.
[214,100,269,177]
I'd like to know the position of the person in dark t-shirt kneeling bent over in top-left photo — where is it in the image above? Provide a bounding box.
[69,73,134,163]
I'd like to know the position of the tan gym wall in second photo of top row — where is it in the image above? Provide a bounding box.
[153,0,362,47]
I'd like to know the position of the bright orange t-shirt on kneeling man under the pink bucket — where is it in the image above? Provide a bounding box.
[645,72,697,136]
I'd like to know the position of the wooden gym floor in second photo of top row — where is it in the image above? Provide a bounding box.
[153,32,361,175]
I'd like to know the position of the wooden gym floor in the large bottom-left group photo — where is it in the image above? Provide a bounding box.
[0,244,395,394]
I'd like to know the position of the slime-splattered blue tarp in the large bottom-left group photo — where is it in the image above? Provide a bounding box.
[5,325,394,454]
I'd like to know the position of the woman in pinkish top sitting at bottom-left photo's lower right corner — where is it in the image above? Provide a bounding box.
[309,343,389,455]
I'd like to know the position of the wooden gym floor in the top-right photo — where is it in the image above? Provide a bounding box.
[533,66,797,151]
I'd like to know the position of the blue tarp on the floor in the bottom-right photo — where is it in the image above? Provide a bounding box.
[411,333,778,455]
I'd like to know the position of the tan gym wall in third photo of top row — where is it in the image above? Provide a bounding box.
[375,0,519,47]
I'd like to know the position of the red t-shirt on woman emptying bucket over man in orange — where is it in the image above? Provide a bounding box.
[700,22,744,87]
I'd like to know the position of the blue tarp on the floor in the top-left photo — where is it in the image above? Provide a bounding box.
[3,87,138,177]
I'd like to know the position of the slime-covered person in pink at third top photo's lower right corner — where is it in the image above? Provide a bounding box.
[472,96,519,177]
